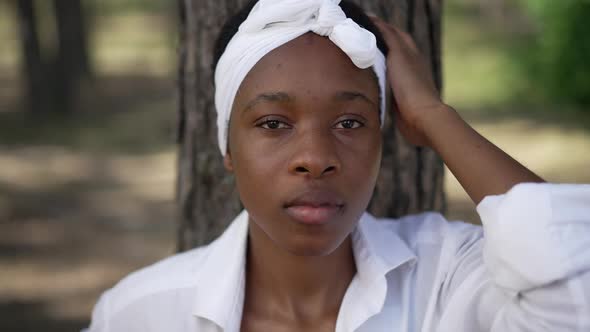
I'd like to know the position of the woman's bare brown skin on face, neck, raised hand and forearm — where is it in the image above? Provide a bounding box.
[224,18,542,331]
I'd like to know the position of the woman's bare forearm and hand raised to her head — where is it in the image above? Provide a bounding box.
[374,18,544,204]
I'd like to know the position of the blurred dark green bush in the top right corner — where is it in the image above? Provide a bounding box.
[522,0,590,105]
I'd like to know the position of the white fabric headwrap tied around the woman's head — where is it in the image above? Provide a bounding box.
[215,0,386,155]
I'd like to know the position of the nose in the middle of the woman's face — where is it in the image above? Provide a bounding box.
[289,130,341,178]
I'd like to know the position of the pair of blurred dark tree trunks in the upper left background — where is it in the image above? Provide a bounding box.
[15,0,91,114]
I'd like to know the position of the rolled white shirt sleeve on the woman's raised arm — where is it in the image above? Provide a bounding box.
[436,183,590,332]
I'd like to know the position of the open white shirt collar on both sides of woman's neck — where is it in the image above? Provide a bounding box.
[193,210,416,331]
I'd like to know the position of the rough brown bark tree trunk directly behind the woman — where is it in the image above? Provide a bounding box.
[177,0,445,251]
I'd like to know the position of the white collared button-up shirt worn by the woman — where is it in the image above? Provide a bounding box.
[89,184,590,332]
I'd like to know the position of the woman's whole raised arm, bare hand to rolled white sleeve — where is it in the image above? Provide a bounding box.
[375,18,590,332]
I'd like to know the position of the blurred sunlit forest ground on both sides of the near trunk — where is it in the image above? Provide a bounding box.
[0,0,590,331]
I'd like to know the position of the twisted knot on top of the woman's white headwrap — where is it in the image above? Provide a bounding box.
[240,0,378,69]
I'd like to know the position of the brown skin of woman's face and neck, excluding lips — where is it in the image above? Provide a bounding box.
[225,33,381,331]
